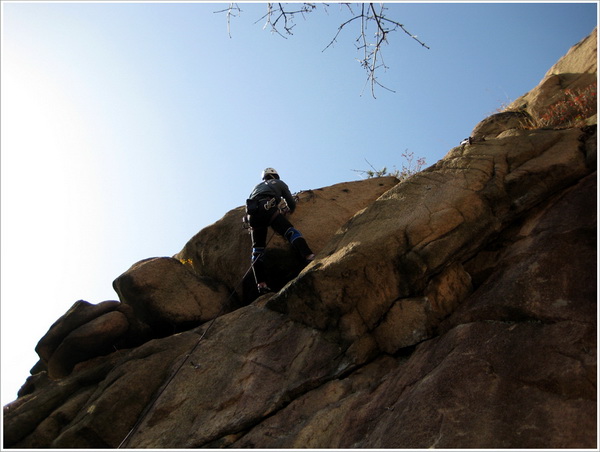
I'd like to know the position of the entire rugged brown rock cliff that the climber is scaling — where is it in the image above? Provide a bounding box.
[4,32,597,449]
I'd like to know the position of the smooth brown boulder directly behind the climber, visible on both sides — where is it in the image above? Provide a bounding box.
[175,177,398,306]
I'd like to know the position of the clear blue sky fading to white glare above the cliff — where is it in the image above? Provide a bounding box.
[1,2,597,405]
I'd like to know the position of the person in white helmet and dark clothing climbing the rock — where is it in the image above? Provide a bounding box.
[246,168,315,294]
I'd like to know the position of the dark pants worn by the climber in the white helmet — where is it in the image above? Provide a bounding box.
[250,203,312,283]
